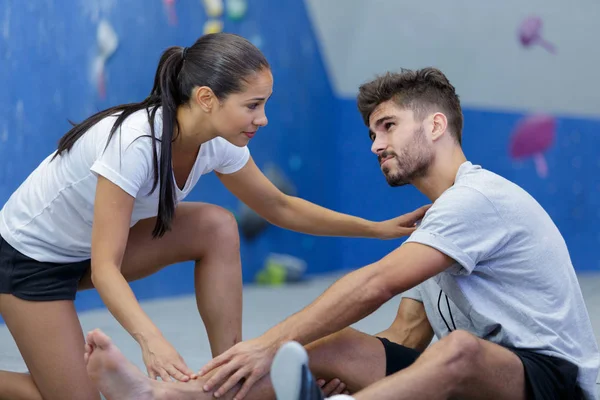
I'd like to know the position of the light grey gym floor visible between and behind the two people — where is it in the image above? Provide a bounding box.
[0,273,600,394]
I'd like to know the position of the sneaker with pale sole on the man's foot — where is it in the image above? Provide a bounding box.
[271,342,325,400]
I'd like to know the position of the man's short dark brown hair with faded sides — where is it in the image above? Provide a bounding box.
[357,67,463,144]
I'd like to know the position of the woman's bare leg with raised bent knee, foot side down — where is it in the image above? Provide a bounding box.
[80,203,242,356]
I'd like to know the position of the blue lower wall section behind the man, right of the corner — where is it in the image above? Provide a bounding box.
[338,100,600,272]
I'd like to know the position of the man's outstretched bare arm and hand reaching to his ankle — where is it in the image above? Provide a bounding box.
[200,243,454,400]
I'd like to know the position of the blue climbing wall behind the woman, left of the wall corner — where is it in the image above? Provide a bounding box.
[0,0,339,309]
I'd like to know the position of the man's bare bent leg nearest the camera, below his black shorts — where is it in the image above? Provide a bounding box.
[353,331,526,400]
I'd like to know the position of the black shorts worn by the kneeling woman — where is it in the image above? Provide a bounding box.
[0,236,90,301]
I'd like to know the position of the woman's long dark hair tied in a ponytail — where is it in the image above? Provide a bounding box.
[54,33,270,237]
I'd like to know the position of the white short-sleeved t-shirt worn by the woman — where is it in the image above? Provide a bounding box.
[0,109,250,263]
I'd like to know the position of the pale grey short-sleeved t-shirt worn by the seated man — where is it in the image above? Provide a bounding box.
[406,162,600,399]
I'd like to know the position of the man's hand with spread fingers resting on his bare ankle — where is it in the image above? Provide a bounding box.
[198,335,278,400]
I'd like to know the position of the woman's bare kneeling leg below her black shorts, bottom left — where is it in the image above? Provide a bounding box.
[0,294,100,400]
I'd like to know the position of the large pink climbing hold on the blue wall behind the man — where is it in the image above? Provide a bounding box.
[510,115,556,178]
